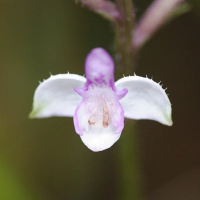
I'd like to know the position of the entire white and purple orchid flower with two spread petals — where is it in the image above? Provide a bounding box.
[30,48,172,151]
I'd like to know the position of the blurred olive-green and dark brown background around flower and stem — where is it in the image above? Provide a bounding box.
[0,0,200,200]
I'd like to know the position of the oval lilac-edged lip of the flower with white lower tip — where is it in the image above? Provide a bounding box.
[74,87,124,151]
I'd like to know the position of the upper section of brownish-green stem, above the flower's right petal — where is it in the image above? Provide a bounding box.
[115,0,135,78]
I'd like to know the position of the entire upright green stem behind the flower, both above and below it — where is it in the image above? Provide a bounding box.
[115,0,142,200]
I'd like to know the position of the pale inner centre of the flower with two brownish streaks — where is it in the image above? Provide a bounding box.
[88,97,110,128]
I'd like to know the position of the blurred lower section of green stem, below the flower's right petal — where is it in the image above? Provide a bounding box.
[118,120,143,200]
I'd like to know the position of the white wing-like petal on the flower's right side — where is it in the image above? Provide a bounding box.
[115,76,172,126]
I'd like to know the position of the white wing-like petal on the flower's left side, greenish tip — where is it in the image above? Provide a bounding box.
[29,74,86,118]
